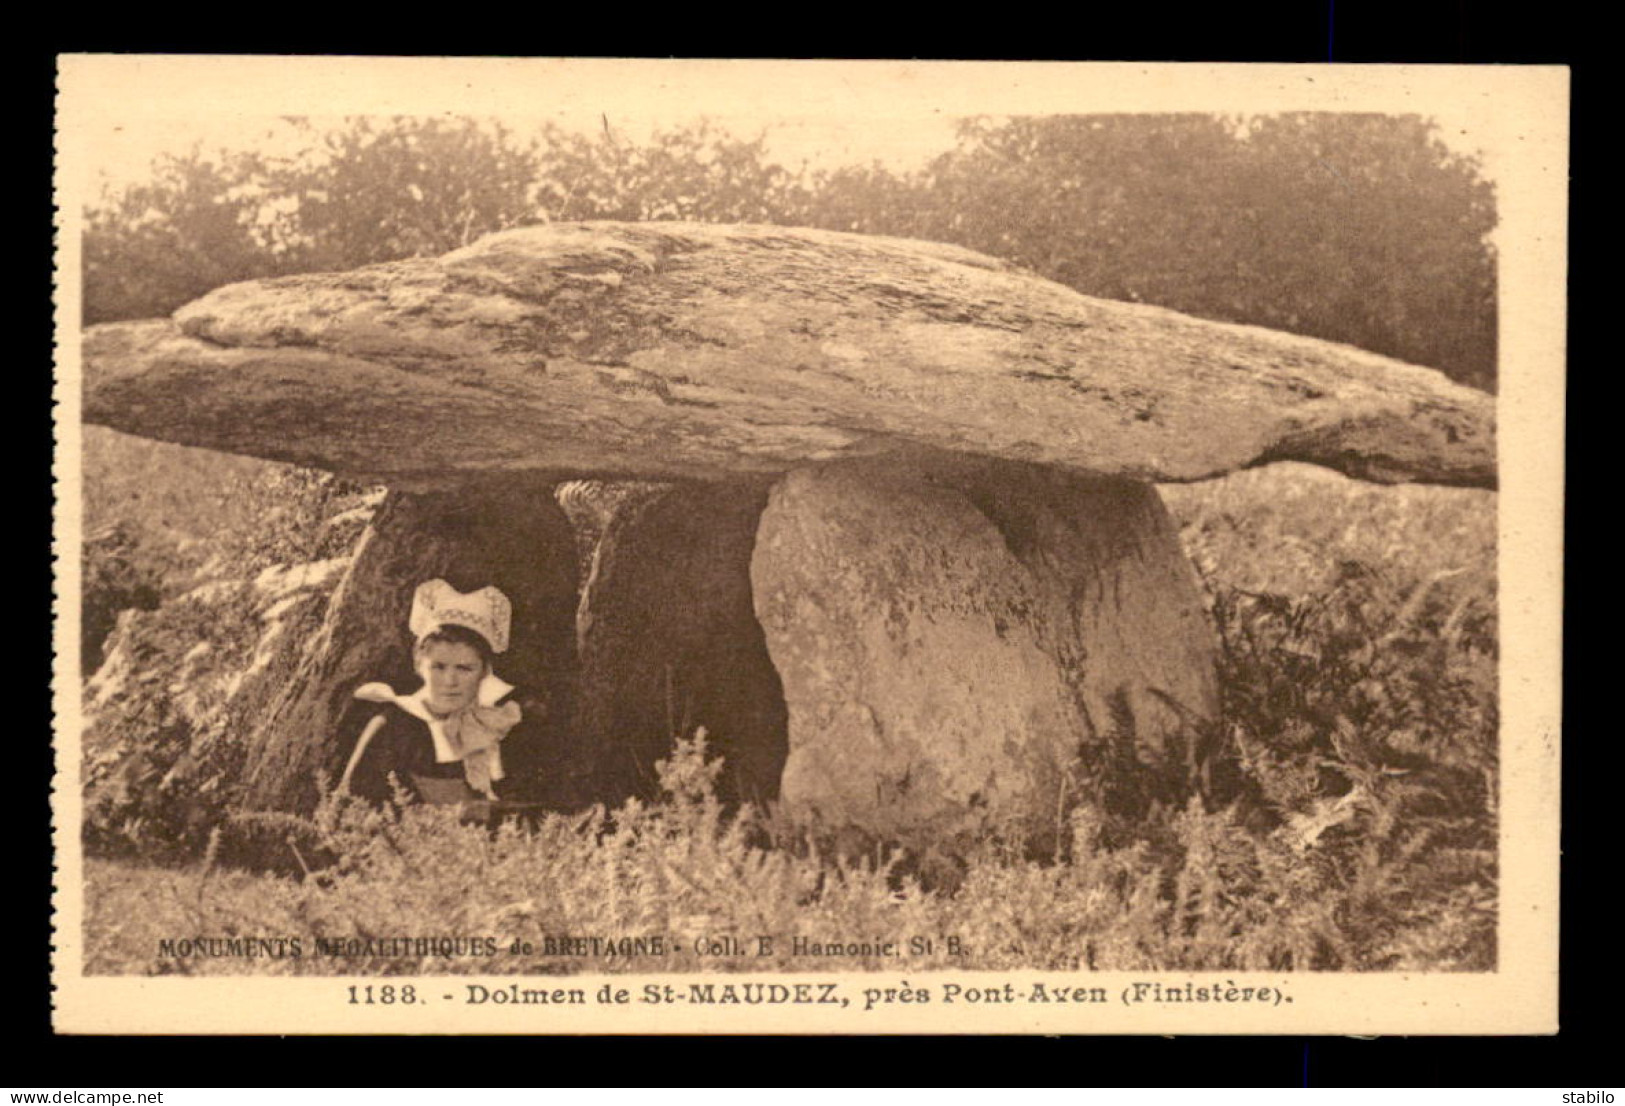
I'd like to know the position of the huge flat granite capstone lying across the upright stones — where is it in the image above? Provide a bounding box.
[85,222,1495,487]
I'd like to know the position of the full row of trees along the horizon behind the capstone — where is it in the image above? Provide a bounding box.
[83,114,1497,390]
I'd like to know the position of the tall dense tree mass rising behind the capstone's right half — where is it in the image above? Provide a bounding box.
[809,114,1495,388]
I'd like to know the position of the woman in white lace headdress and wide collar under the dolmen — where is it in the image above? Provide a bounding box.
[340,580,520,802]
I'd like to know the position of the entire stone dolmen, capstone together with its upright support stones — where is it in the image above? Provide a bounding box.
[83,222,1495,835]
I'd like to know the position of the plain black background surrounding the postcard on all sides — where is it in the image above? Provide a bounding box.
[28,0,1599,1084]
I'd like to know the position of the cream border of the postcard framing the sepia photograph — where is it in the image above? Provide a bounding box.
[52,55,1570,1035]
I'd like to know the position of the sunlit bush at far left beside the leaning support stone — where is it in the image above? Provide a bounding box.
[83,456,377,862]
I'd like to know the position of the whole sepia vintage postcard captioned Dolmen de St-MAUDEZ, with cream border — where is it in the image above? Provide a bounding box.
[50,55,1568,1035]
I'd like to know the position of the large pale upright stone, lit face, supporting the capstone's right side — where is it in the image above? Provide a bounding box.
[751,463,1217,835]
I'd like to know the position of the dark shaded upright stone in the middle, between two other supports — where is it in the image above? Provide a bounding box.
[577,484,785,802]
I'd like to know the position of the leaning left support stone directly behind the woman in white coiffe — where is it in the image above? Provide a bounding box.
[235,484,590,809]
